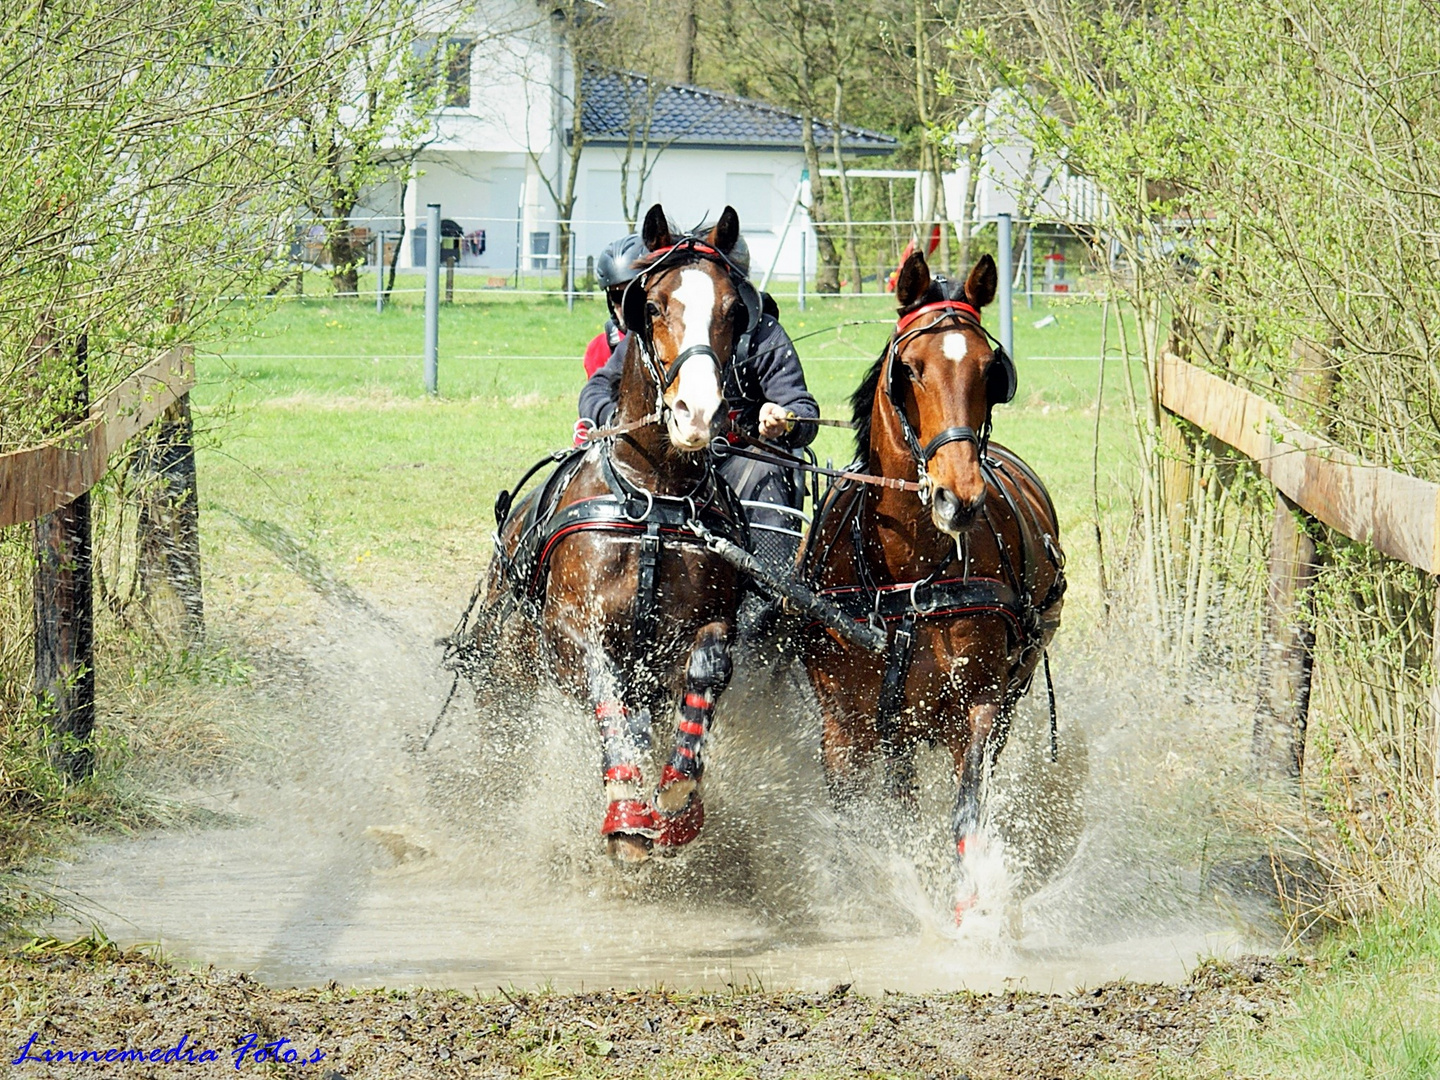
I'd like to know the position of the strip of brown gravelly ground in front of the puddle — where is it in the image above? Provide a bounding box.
[0,948,1295,1080]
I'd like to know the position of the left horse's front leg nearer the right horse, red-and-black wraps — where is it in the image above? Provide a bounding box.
[655,622,732,848]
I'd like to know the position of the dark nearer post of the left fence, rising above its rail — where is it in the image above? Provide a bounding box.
[35,336,95,779]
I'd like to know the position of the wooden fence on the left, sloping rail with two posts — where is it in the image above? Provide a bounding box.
[0,351,203,778]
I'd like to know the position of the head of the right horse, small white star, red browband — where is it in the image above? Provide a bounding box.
[884,252,1015,540]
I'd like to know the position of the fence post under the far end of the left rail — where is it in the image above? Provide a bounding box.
[135,393,204,645]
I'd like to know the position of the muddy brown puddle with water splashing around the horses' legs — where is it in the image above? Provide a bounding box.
[37,601,1273,992]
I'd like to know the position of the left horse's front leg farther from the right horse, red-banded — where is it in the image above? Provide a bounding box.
[586,648,660,863]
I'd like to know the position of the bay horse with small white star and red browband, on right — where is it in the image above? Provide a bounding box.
[799,252,1066,922]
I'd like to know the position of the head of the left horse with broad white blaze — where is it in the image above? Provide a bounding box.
[621,203,760,454]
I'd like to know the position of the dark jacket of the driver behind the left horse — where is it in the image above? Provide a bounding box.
[580,315,819,448]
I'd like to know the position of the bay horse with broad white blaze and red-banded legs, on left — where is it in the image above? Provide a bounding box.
[477,203,760,863]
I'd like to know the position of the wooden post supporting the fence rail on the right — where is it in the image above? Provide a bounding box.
[1251,341,1335,780]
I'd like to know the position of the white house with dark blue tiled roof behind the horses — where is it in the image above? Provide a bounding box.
[357,0,896,276]
